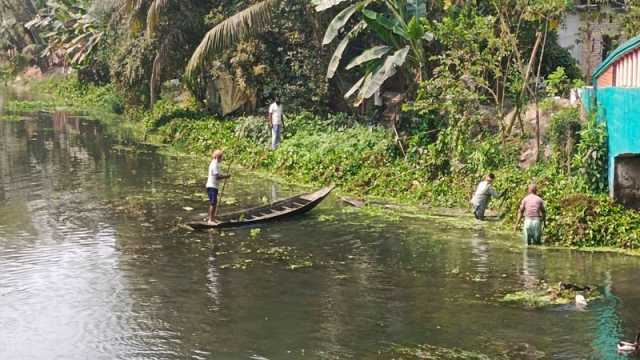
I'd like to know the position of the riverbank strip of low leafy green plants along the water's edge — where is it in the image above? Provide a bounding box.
[3,75,640,252]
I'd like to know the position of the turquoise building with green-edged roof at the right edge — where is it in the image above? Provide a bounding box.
[592,36,640,209]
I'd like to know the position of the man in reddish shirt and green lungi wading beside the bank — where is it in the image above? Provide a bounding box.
[513,184,546,245]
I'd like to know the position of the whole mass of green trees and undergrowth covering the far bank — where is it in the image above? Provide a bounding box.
[0,0,640,249]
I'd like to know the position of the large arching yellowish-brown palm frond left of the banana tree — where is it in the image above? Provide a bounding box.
[186,0,280,77]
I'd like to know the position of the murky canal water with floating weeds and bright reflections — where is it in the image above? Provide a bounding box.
[0,91,640,359]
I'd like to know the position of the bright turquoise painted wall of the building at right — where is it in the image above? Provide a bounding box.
[596,87,640,195]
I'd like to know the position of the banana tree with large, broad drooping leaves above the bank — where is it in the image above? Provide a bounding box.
[313,0,433,105]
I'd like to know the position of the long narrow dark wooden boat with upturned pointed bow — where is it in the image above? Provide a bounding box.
[187,186,333,229]
